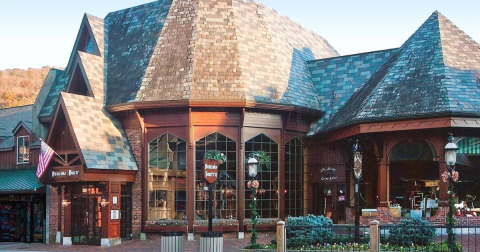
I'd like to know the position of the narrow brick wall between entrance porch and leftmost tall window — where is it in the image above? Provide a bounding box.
[125,128,143,238]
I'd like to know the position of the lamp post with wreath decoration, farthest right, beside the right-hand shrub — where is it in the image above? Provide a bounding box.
[442,133,458,251]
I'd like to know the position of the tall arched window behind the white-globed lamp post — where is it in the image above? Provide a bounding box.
[244,134,279,218]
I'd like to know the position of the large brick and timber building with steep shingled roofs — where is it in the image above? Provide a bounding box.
[28,0,480,246]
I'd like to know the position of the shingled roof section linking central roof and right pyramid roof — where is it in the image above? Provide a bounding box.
[308,49,397,135]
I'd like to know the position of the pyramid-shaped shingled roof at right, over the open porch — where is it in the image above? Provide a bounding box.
[321,12,480,134]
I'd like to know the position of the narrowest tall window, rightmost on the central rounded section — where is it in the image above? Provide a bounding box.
[284,137,305,217]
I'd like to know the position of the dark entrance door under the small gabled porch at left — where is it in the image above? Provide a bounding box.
[72,185,102,245]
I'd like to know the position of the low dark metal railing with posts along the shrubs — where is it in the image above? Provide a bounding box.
[277,221,480,252]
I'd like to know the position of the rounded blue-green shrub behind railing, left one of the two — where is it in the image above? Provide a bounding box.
[287,214,334,248]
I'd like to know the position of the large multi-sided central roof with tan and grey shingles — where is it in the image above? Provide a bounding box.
[105,0,338,110]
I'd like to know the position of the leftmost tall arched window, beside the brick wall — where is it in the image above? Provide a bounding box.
[147,133,187,220]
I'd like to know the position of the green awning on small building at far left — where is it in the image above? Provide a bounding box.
[0,169,44,194]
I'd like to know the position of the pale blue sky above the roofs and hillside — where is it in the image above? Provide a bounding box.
[0,0,480,70]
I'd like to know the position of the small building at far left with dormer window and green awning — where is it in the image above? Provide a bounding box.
[0,105,48,242]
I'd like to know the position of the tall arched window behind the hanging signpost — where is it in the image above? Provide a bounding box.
[195,132,237,220]
